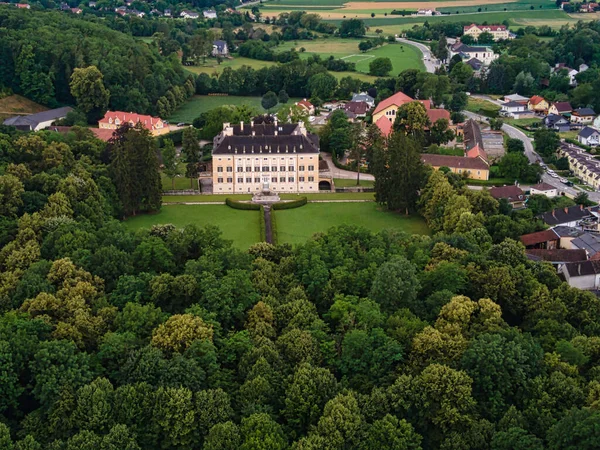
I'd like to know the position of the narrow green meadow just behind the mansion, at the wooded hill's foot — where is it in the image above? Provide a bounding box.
[169,95,300,123]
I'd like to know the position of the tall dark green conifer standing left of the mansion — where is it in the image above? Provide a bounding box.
[109,125,162,216]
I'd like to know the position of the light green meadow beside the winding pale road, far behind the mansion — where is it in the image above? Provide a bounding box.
[277,38,425,74]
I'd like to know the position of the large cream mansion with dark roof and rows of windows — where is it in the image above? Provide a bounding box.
[212,120,319,194]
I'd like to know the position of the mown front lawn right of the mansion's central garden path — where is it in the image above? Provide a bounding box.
[274,202,429,244]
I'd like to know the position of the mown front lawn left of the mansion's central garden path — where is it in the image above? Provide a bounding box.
[124,205,260,249]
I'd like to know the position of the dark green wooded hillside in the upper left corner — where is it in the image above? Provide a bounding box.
[0,7,193,113]
